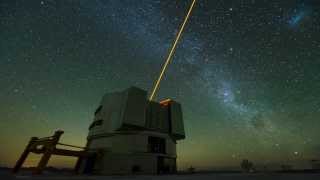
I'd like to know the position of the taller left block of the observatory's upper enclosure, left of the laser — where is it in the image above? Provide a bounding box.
[89,87,147,135]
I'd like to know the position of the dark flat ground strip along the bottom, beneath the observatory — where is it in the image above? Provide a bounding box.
[0,171,320,180]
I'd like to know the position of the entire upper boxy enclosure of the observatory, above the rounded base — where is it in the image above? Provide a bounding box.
[89,87,185,140]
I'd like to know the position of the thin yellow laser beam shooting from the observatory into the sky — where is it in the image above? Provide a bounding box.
[149,0,196,101]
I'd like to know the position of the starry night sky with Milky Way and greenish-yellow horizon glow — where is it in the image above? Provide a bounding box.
[0,0,320,169]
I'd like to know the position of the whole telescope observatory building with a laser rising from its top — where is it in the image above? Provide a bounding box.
[79,87,185,174]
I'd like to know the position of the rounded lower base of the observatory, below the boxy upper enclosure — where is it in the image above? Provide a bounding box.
[80,131,176,175]
